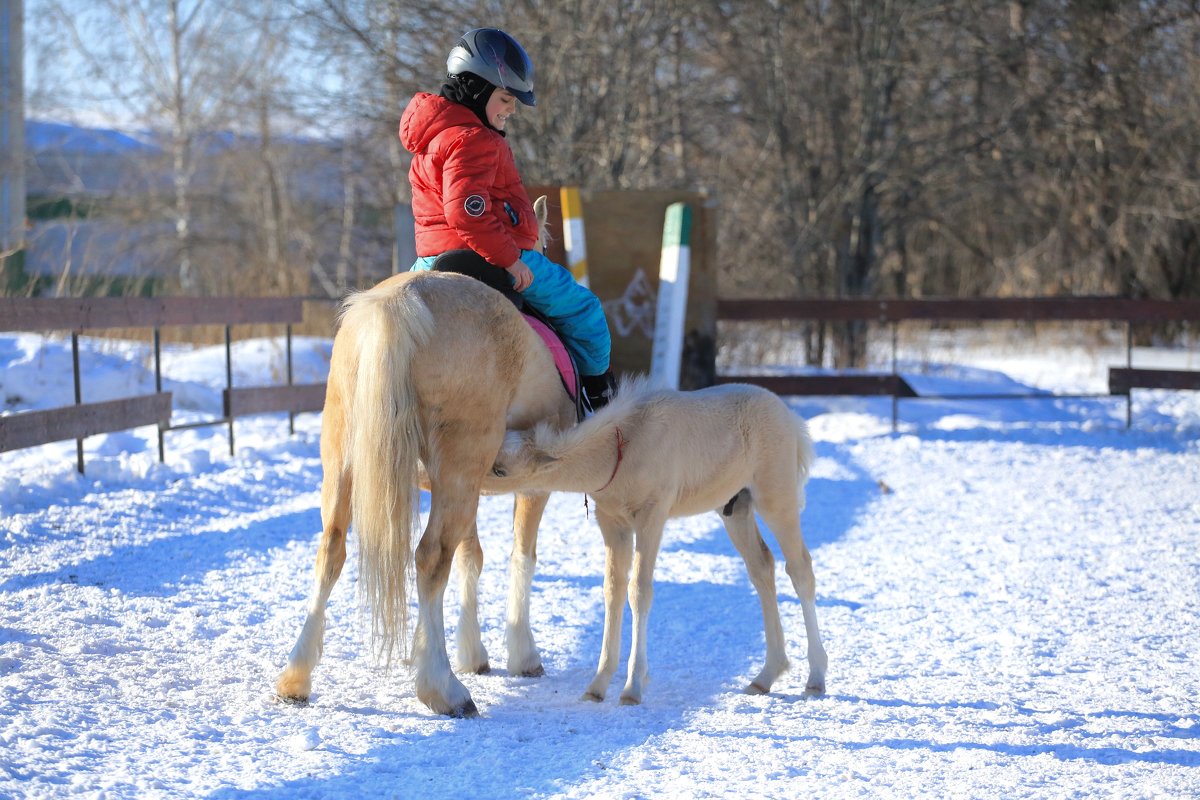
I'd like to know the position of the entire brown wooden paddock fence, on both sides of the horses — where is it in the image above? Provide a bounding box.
[0,297,1200,473]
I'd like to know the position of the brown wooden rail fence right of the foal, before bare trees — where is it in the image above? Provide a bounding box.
[716,297,1200,429]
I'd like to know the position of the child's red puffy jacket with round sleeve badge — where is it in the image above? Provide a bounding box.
[400,92,538,267]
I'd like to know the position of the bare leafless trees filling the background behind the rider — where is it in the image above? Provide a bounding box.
[18,0,1200,352]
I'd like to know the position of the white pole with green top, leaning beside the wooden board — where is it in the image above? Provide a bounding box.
[650,203,691,389]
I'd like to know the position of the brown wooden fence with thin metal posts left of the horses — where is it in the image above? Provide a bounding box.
[0,297,325,473]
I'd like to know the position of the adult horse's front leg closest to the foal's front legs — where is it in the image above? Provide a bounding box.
[505,492,550,678]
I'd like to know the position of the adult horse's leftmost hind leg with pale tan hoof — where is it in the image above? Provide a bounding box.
[275,450,350,700]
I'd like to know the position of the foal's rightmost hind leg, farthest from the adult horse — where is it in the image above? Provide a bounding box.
[754,489,829,694]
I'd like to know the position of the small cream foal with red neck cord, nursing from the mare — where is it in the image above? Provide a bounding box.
[492,378,828,704]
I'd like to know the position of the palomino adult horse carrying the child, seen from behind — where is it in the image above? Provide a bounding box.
[276,203,575,716]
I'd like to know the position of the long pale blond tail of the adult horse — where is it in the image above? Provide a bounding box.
[342,284,433,664]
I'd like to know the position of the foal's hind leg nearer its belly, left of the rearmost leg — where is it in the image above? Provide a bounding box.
[721,489,787,694]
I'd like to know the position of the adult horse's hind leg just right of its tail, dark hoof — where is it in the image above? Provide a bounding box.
[413,479,479,717]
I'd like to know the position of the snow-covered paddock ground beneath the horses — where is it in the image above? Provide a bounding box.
[0,335,1200,798]
